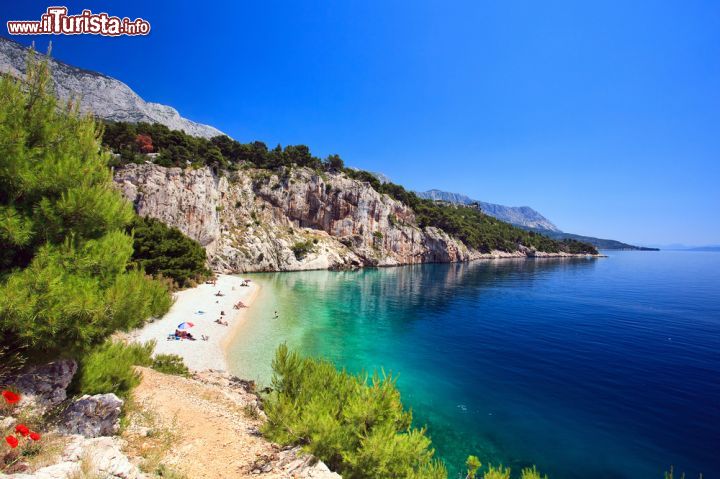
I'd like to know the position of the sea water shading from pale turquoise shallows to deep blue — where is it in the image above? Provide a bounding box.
[230,251,720,479]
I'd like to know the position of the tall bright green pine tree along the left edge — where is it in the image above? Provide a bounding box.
[0,50,170,362]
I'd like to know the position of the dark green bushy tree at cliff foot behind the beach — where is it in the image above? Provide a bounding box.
[129,217,210,288]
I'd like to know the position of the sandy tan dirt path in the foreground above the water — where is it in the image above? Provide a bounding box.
[123,368,339,479]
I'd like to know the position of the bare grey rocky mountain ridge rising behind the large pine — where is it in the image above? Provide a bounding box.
[0,37,223,138]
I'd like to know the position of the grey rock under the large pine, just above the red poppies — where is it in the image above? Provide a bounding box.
[4,359,77,412]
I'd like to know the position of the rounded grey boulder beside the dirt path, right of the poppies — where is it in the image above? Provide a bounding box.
[59,393,123,437]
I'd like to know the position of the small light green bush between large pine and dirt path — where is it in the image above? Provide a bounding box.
[78,340,155,398]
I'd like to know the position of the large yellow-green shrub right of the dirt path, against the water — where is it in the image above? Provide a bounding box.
[263,345,447,479]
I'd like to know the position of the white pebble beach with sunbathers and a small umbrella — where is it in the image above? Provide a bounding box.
[130,275,260,371]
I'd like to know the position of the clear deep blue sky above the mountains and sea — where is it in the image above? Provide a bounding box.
[0,0,720,248]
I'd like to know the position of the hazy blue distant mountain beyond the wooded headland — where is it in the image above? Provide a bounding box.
[417,190,657,251]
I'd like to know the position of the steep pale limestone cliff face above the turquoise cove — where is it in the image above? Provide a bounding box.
[115,163,477,272]
